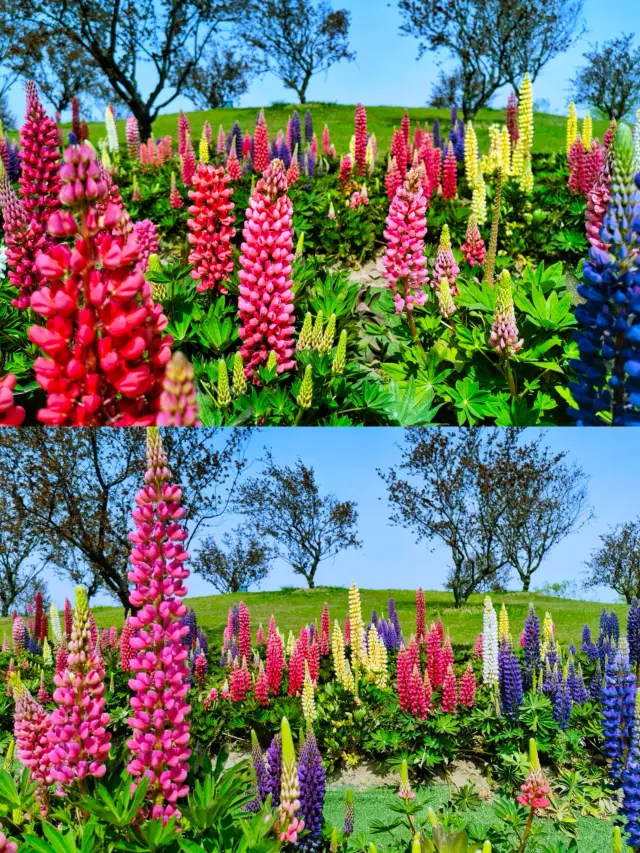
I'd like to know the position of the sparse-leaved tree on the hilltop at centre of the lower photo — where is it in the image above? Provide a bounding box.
[236,453,362,589]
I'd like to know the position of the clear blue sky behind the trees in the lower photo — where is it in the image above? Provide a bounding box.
[49,427,640,605]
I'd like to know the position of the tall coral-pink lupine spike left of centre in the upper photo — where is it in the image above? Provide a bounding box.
[238,159,295,382]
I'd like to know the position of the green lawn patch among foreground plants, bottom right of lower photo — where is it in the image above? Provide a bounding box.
[324,784,613,853]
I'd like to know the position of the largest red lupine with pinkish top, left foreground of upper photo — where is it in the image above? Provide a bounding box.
[29,145,173,426]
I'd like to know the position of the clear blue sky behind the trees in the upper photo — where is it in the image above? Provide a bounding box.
[5,0,637,121]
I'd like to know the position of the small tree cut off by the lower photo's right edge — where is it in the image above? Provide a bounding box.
[584,517,640,604]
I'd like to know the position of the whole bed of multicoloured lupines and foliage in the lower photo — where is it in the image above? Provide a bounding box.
[0,428,640,853]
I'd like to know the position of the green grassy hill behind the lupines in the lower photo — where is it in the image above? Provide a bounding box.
[5,587,627,646]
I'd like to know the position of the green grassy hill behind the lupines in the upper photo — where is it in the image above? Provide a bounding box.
[72,104,607,154]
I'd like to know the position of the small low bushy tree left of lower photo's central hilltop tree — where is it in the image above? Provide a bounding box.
[193,525,276,592]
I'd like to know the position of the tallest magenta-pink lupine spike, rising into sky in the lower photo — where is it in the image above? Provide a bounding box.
[127,427,191,822]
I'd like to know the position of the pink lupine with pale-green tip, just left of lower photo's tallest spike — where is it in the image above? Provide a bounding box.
[48,586,111,785]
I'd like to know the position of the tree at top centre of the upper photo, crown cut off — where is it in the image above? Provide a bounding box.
[240,0,355,104]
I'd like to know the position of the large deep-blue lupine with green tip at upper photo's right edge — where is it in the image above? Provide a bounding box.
[569,124,640,426]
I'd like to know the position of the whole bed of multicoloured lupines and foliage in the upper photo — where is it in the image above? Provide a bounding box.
[0,76,640,426]
